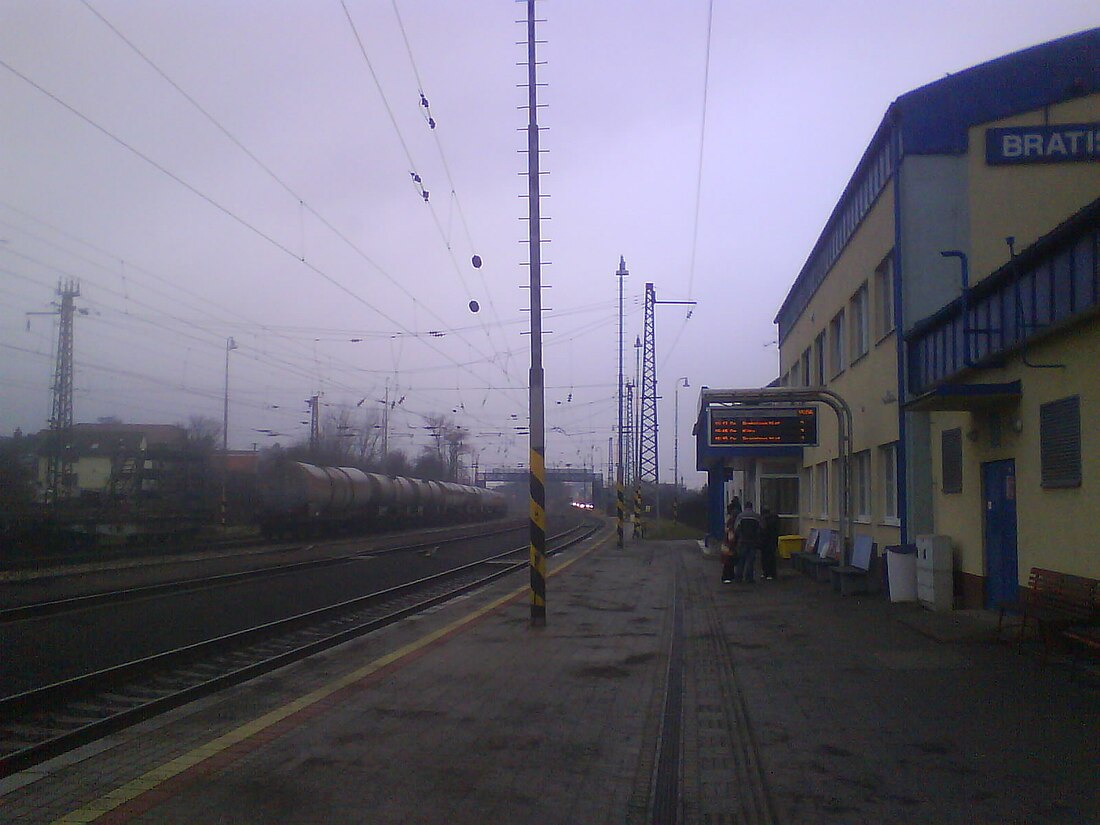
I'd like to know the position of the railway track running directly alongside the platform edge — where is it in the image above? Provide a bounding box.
[0,524,598,777]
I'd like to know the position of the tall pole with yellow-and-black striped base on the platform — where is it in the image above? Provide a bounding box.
[527,0,547,627]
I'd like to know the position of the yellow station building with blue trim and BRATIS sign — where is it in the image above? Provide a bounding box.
[697,29,1100,607]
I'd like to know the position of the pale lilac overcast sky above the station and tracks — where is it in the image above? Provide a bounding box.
[0,0,1100,484]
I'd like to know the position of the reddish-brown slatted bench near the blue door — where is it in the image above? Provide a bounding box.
[997,568,1100,666]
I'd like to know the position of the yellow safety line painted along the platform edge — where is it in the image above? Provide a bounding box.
[53,525,612,825]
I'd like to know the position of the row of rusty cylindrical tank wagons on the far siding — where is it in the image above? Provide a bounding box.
[260,461,507,537]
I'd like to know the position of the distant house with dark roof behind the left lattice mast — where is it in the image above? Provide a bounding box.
[39,424,187,497]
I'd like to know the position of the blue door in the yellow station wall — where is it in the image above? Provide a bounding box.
[981,459,1020,607]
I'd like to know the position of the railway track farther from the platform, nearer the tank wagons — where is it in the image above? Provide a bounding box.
[0,523,527,625]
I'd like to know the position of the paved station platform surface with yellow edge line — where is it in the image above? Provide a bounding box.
[0,530,1100,825]
